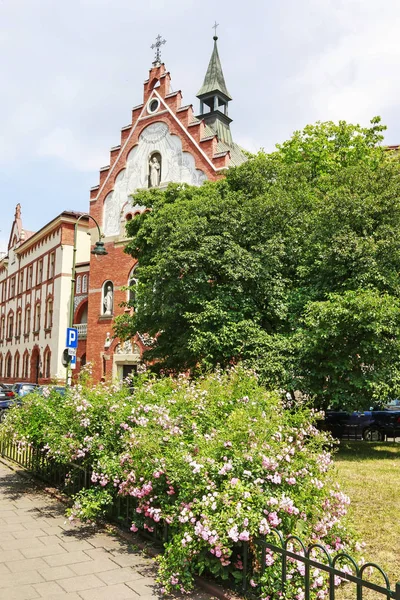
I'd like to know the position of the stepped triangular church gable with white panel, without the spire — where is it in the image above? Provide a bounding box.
[90,63,232,235]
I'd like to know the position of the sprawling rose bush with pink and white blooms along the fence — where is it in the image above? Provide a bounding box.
[0,367,355,600]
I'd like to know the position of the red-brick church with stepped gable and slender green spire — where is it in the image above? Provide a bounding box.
[74,36,246,380]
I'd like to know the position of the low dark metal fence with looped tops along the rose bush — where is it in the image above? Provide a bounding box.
[0,440,400,600]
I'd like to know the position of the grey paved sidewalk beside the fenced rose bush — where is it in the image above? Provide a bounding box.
[0,463,209,600]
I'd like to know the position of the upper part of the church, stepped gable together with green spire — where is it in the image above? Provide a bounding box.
[90,36,246,237]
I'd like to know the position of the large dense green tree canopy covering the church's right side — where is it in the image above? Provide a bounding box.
[116,118,400,406]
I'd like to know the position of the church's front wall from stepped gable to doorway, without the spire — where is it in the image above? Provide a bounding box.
[87,58,238,381]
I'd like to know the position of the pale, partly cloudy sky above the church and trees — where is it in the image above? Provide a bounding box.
[0,0,400,251]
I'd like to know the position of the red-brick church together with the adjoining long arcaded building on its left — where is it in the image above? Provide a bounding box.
[0,36,246,383]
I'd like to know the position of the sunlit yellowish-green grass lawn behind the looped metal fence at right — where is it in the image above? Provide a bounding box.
[335,442,400,598]
